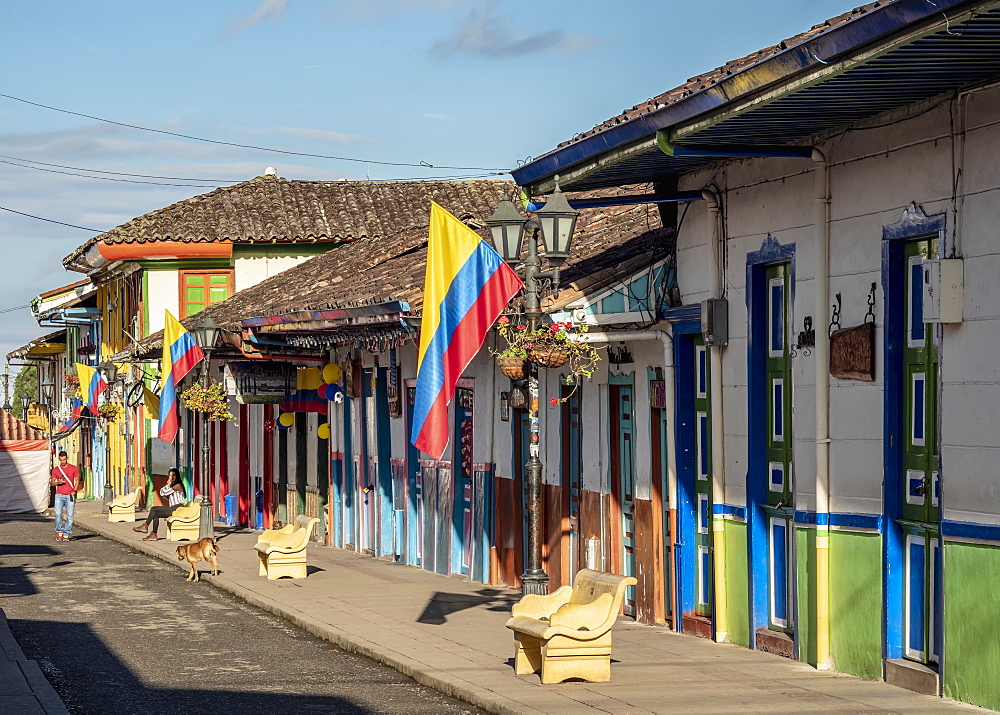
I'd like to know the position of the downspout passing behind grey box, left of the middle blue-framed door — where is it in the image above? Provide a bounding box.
[702,189,729,643]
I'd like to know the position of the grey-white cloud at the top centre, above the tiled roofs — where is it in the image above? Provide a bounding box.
[430,0,606,59]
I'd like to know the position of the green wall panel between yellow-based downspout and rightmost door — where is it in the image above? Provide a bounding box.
[830,531,882,680]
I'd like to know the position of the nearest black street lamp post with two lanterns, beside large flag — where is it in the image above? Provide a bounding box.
[486,176,579,595]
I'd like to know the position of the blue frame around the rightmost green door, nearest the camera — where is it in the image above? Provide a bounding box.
[882,204,946,667]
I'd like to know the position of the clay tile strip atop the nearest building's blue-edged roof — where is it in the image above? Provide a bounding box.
[559,0,880,148]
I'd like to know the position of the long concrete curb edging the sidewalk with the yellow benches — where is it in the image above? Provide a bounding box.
[74,518,541,715]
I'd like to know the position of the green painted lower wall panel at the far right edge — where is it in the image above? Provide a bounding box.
[944,542,1000,710]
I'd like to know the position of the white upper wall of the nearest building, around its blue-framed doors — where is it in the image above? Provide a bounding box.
[678,89,1000,523]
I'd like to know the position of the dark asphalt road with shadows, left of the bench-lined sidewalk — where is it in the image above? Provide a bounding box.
[0,516,482,713]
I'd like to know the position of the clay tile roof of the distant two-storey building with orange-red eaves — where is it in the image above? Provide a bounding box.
[63,175,512,265]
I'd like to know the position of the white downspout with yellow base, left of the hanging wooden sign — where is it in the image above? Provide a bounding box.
[812,149,830,670]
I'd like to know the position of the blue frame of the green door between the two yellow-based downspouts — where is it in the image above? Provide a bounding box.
[746,235,798,653]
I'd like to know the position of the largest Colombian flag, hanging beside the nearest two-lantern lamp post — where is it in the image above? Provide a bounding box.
[410,201,523,459]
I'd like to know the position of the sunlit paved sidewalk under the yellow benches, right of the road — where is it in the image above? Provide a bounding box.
[76,501,986,713]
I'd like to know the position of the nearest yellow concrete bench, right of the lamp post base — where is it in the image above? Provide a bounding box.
[507,569,636,684]
